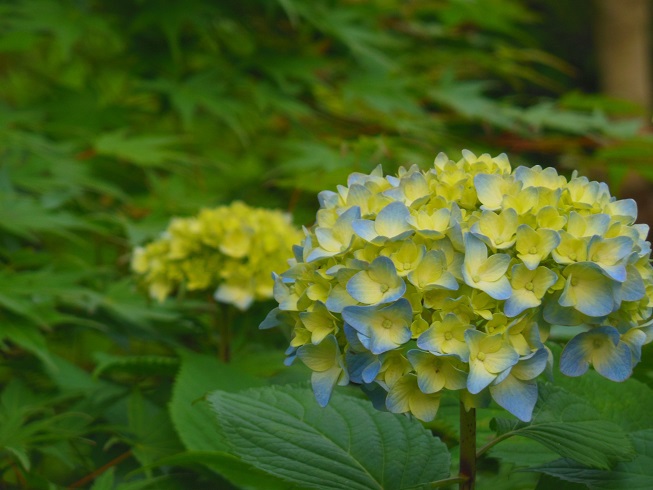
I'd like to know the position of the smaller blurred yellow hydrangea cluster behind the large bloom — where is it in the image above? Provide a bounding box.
[132,202,301,310]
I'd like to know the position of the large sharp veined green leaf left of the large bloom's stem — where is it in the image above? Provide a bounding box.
[209,386,449,490]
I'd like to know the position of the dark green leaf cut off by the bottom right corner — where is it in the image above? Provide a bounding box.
[529,429,653,490]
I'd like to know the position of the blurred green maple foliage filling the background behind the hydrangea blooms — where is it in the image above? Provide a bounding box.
[0,0,653,488]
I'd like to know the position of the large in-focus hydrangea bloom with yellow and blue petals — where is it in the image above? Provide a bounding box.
[261,151,653,421]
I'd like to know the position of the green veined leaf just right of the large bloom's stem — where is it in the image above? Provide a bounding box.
[488,384,634,469]
